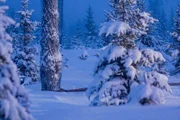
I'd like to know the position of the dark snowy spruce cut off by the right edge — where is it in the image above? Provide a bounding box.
[171,4,180,73]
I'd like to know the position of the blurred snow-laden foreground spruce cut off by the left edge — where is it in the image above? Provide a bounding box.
[0,0,33,120]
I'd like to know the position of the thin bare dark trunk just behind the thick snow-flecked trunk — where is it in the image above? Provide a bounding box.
[58,0,64,44]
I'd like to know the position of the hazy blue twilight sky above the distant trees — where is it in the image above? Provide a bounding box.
[7,0,180,31]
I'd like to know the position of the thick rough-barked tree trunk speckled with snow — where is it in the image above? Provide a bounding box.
[40,0,62,91]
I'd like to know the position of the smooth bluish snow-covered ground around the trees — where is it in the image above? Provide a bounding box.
[26,50,180,120]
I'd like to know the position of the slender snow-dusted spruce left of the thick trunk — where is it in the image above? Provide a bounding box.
[13,0,39,84]
